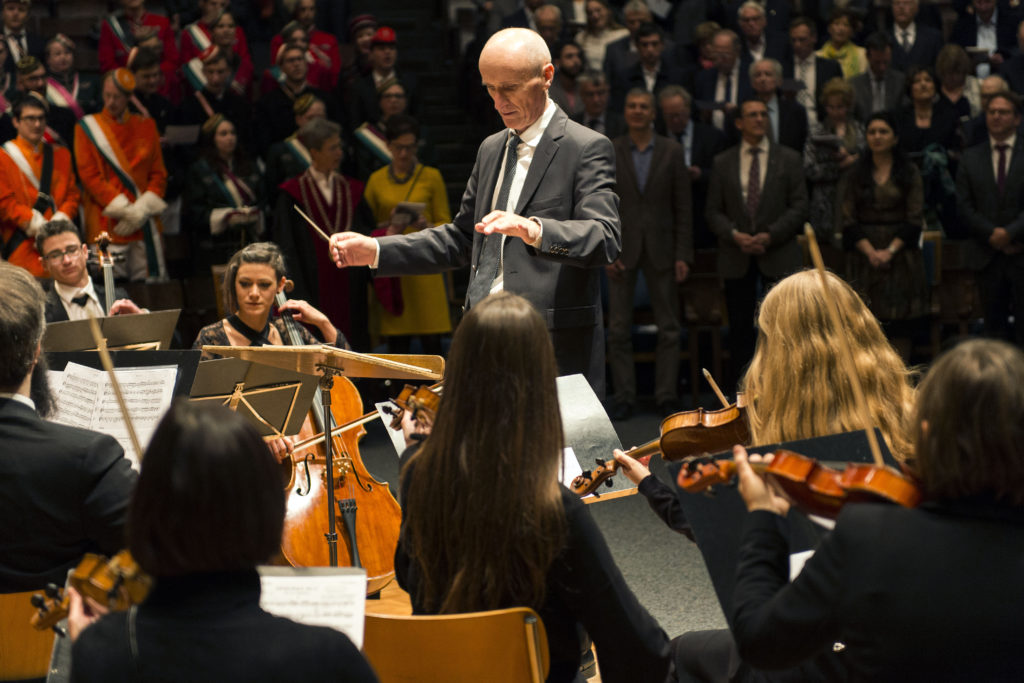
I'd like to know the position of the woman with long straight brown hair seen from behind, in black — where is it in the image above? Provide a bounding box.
[395,292,671,683]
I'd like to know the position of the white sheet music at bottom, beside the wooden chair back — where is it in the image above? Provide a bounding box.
[259,566,367,649]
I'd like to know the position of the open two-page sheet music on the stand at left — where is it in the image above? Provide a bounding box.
[52,362,178,469]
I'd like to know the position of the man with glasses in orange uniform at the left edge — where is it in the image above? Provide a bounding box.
[0,92,79,278]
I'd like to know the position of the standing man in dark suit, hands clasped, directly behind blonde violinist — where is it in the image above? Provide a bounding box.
[708,99,807,376]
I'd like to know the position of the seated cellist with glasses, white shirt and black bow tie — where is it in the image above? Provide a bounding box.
[36,220,146,323]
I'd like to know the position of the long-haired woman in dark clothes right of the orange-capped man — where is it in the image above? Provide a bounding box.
[181,114,266,268]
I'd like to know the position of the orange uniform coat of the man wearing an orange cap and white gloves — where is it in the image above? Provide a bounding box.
[75,109,167,244]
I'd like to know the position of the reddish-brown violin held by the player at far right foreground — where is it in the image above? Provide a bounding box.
[676,450,922,519]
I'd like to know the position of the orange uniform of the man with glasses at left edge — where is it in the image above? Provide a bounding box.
[0,135,79,278]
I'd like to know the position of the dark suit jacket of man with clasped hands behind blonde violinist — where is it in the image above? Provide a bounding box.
[707,144,807,279]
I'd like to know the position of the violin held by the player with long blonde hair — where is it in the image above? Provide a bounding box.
[569,392,751,497]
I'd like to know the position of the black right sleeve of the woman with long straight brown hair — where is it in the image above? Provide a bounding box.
[549,489,670,681]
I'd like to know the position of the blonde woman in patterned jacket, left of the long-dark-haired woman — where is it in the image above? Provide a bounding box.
[804,78,864,244]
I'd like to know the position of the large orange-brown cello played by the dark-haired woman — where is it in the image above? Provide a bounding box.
[278,292,401,595]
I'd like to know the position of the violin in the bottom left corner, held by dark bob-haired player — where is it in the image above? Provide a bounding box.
[29,550,153,636]
